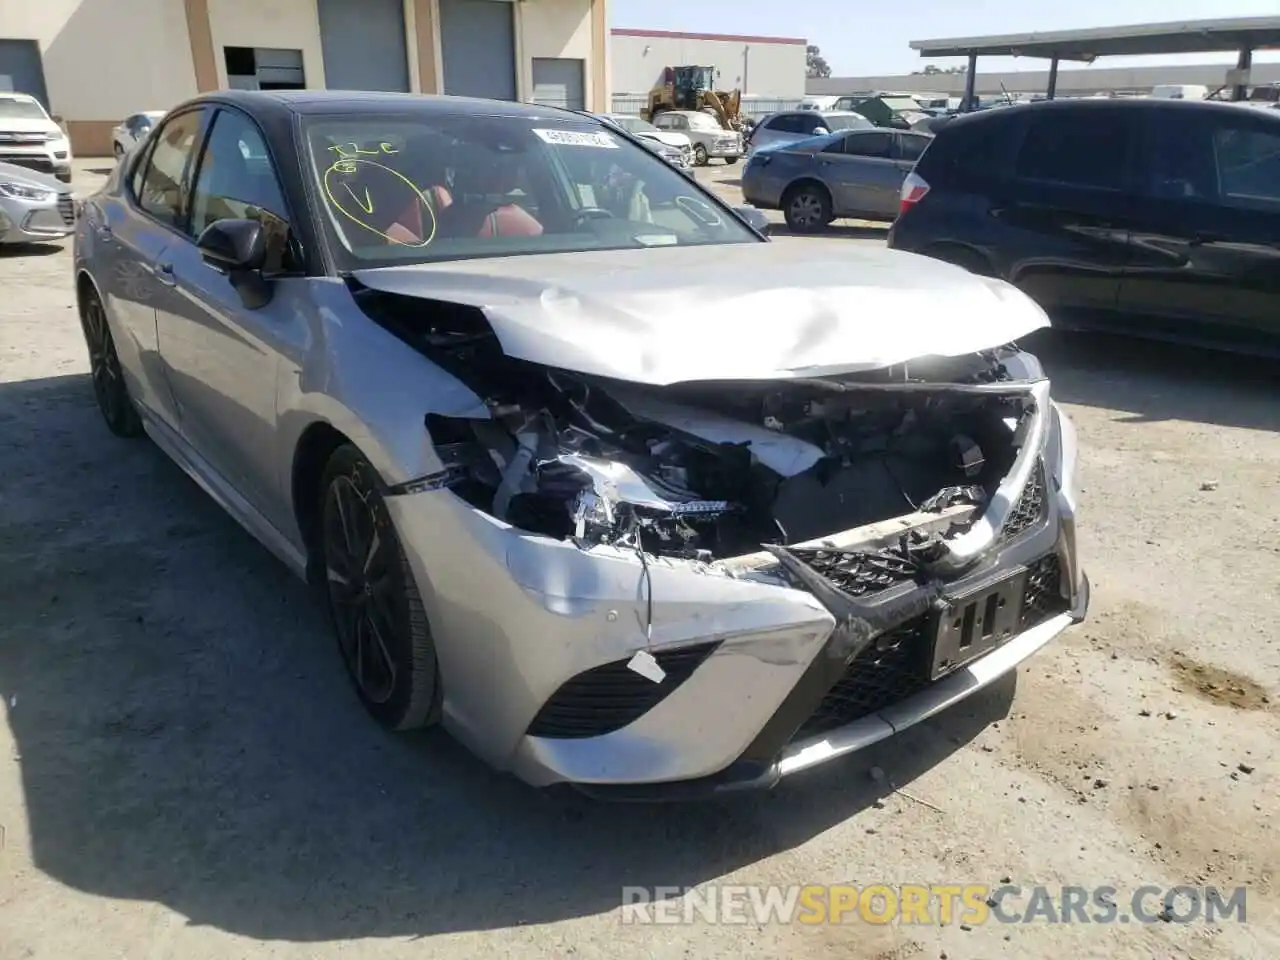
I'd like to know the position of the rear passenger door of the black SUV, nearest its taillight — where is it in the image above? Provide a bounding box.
[988,104,1143,324]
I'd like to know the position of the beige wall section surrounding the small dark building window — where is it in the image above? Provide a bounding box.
[203,0,324,87]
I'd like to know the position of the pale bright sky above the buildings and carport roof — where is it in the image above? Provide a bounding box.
[609,0,1280,77]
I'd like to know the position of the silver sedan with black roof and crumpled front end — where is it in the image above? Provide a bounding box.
[76,91,1088,797]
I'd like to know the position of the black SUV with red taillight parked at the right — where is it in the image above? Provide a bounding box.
[888,100,1280,353]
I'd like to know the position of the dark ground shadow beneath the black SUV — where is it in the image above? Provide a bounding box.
[1021,329,1280,431]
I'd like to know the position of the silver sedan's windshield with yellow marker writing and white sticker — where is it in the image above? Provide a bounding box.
[303,115,759,271]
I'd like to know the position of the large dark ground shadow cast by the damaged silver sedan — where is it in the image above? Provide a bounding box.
[0,375,1015,942]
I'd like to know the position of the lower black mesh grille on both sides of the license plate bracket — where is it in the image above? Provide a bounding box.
[791,553,1069,740]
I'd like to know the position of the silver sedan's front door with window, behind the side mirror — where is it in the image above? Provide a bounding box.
[157,108,306,529]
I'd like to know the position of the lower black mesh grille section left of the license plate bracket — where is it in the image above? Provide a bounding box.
[794,617,929,739]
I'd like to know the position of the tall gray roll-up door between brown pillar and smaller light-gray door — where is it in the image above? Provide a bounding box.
[440,0,516,100]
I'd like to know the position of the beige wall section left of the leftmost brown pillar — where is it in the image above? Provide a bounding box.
[0,0,196,124]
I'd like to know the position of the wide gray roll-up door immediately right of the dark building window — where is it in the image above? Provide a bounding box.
[319,0,410,92]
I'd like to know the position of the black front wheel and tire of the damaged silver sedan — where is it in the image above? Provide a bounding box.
[320,444,439,730]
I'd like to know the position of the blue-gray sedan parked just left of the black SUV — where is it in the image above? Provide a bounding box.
[742,129,932,233]
